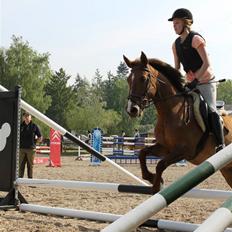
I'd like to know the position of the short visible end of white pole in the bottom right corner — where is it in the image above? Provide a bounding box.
[194,197,232,232]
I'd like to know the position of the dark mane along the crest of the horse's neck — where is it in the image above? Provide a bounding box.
[148,58,184,92]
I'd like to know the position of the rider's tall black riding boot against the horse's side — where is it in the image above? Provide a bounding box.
[210,112,225,153]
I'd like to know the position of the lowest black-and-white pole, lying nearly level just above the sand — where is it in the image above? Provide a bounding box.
[19,204,232,232]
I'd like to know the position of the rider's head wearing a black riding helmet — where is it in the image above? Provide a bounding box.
[168,8,193,35]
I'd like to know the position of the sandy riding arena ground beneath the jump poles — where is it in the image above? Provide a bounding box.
[0,157,230,232]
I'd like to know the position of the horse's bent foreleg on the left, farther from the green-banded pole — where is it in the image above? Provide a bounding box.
[139,143,166,184]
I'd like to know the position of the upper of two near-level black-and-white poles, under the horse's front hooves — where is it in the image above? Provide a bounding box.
[15,178,232,200]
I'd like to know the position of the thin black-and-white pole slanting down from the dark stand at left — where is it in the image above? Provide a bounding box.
[0,85,149,186]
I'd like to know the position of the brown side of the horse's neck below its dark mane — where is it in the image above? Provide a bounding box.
[153,76,183,117]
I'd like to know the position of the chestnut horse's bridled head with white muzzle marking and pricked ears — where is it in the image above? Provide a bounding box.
[123,52,158,117]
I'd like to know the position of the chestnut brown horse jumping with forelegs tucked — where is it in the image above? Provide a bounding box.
[123,52,232,193]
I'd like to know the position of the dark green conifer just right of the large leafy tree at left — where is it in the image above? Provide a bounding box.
[46,68,75,128]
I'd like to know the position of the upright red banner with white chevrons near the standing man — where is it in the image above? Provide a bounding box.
[50,128,61,167]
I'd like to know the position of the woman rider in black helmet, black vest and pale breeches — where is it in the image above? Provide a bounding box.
[168,8,225,152]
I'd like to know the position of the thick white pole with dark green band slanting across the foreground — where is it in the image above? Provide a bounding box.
[102,144,232,232]
